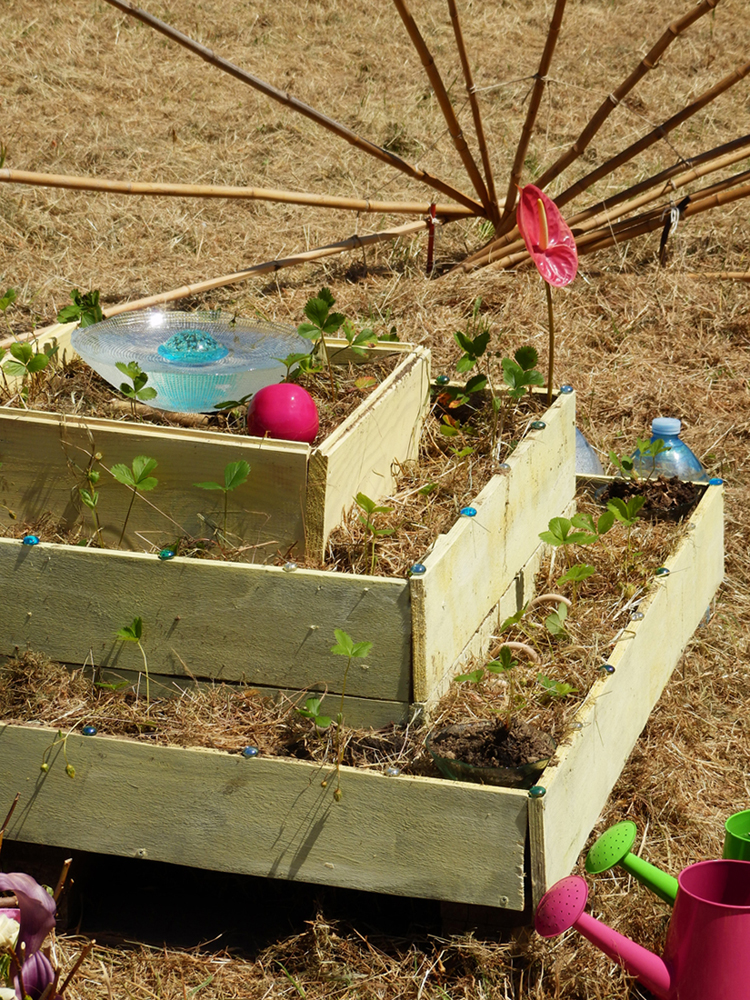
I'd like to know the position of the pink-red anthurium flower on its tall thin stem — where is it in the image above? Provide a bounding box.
[516,184,578,405]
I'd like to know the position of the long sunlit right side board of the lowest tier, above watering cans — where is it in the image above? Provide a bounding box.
[529,486,724,903]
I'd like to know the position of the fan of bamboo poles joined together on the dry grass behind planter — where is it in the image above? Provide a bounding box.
[0,0,750,304]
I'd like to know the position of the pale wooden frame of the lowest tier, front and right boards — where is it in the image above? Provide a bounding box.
[0,486,723,910]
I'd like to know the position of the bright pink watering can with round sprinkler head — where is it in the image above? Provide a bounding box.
[534,860,750,1000]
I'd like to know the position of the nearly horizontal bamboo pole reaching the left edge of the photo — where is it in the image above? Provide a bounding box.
[0,167,475,218]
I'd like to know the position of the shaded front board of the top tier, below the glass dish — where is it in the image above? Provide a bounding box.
[0,407,310,561]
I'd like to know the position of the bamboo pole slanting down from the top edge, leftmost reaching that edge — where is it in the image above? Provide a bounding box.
[100,0,486,215]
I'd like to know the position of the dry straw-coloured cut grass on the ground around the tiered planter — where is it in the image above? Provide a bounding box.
[0,0,750,1000]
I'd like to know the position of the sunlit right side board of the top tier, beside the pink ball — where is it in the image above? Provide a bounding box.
[308,345,430,554]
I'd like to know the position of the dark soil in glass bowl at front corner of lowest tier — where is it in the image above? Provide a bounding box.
[430,718,555,784]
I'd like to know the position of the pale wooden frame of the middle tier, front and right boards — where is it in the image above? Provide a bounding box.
[0,382,575,726]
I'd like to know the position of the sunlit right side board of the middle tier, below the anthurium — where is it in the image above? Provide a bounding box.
[412,393,575,701]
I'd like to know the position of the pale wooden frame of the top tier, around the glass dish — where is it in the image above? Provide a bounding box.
[0,323,430,562]
